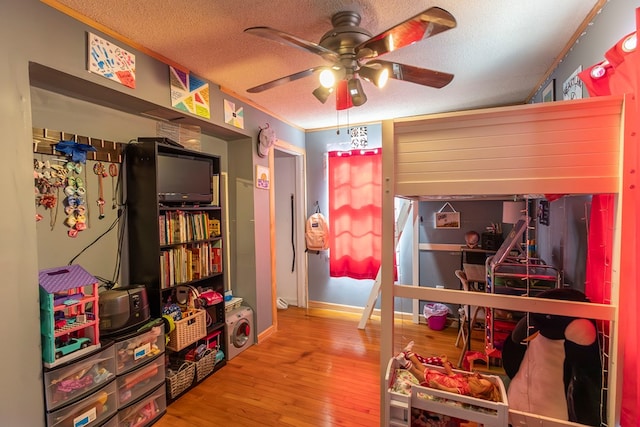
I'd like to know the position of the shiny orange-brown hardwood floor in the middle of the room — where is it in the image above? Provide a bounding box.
[155,307,500,427]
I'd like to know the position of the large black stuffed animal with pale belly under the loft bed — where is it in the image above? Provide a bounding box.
[502,289,604,426]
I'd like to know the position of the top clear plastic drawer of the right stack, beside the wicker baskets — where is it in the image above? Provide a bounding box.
[116,320,164,375]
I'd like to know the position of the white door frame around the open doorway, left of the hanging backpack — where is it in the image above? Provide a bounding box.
[269,140,309,324]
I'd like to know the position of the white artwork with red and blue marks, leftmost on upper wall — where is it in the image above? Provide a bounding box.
[87,33,136,89]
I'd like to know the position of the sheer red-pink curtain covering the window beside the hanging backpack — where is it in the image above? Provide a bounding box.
[329,148,382,279]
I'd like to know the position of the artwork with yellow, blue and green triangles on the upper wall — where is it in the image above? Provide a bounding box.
[169,66,211,119]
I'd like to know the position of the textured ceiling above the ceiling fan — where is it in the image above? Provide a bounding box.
[47,0,603,129]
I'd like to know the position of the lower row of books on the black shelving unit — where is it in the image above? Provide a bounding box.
[160,242,222,289]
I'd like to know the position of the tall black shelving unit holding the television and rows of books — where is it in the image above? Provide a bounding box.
[125,138,226,398]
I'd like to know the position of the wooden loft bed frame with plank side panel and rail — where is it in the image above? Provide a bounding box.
[380,96,625,426]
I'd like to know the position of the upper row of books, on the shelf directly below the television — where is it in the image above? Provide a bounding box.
[158,211,221,245]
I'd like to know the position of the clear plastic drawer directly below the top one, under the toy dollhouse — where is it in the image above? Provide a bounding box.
[47,380,117,427]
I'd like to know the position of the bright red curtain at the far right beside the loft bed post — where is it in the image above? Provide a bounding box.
[580,12,640,426]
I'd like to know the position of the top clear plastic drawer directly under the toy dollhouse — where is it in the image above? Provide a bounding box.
[44,344,116,411]
